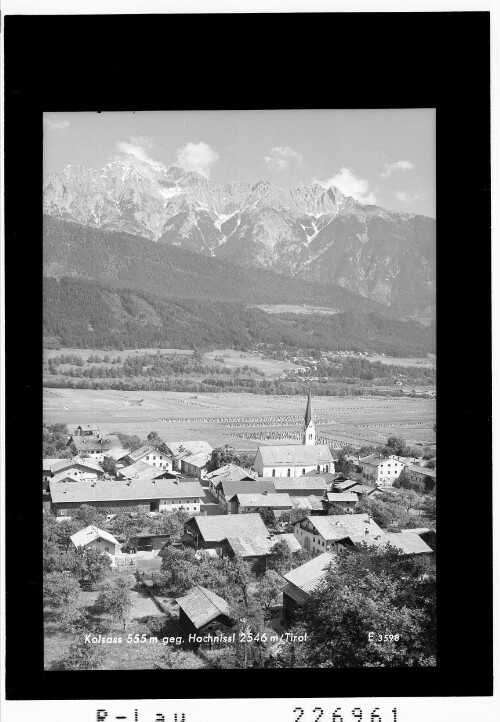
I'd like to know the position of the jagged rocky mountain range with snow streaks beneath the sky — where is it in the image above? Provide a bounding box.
[44,156,435,317]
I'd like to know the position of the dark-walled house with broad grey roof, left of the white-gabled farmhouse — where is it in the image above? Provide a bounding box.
[184,514,269,555]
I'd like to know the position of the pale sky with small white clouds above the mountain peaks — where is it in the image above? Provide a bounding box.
[44,108,435,217]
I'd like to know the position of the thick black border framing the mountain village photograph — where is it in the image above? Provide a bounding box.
[4,12,493,700]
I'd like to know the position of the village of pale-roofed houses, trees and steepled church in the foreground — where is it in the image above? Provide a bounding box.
[43,392,436,668]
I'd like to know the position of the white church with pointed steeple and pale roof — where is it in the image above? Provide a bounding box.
[254,391,335,477]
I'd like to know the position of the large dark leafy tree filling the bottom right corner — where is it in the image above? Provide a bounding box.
[288,544,436,668]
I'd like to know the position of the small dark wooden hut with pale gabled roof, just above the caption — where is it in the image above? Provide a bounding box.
[175,584,234,646]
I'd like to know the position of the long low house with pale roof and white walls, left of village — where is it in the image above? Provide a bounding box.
[50,478,205,519]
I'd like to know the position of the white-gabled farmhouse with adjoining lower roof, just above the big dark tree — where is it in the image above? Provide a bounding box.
[294,514,432,554]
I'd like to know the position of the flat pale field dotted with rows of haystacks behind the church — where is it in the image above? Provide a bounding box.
[43,389,436,449]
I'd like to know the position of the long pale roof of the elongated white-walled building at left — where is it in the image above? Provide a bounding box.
[50,479,203,504]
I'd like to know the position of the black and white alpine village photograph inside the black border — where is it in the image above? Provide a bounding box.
[43,108,437,670]
